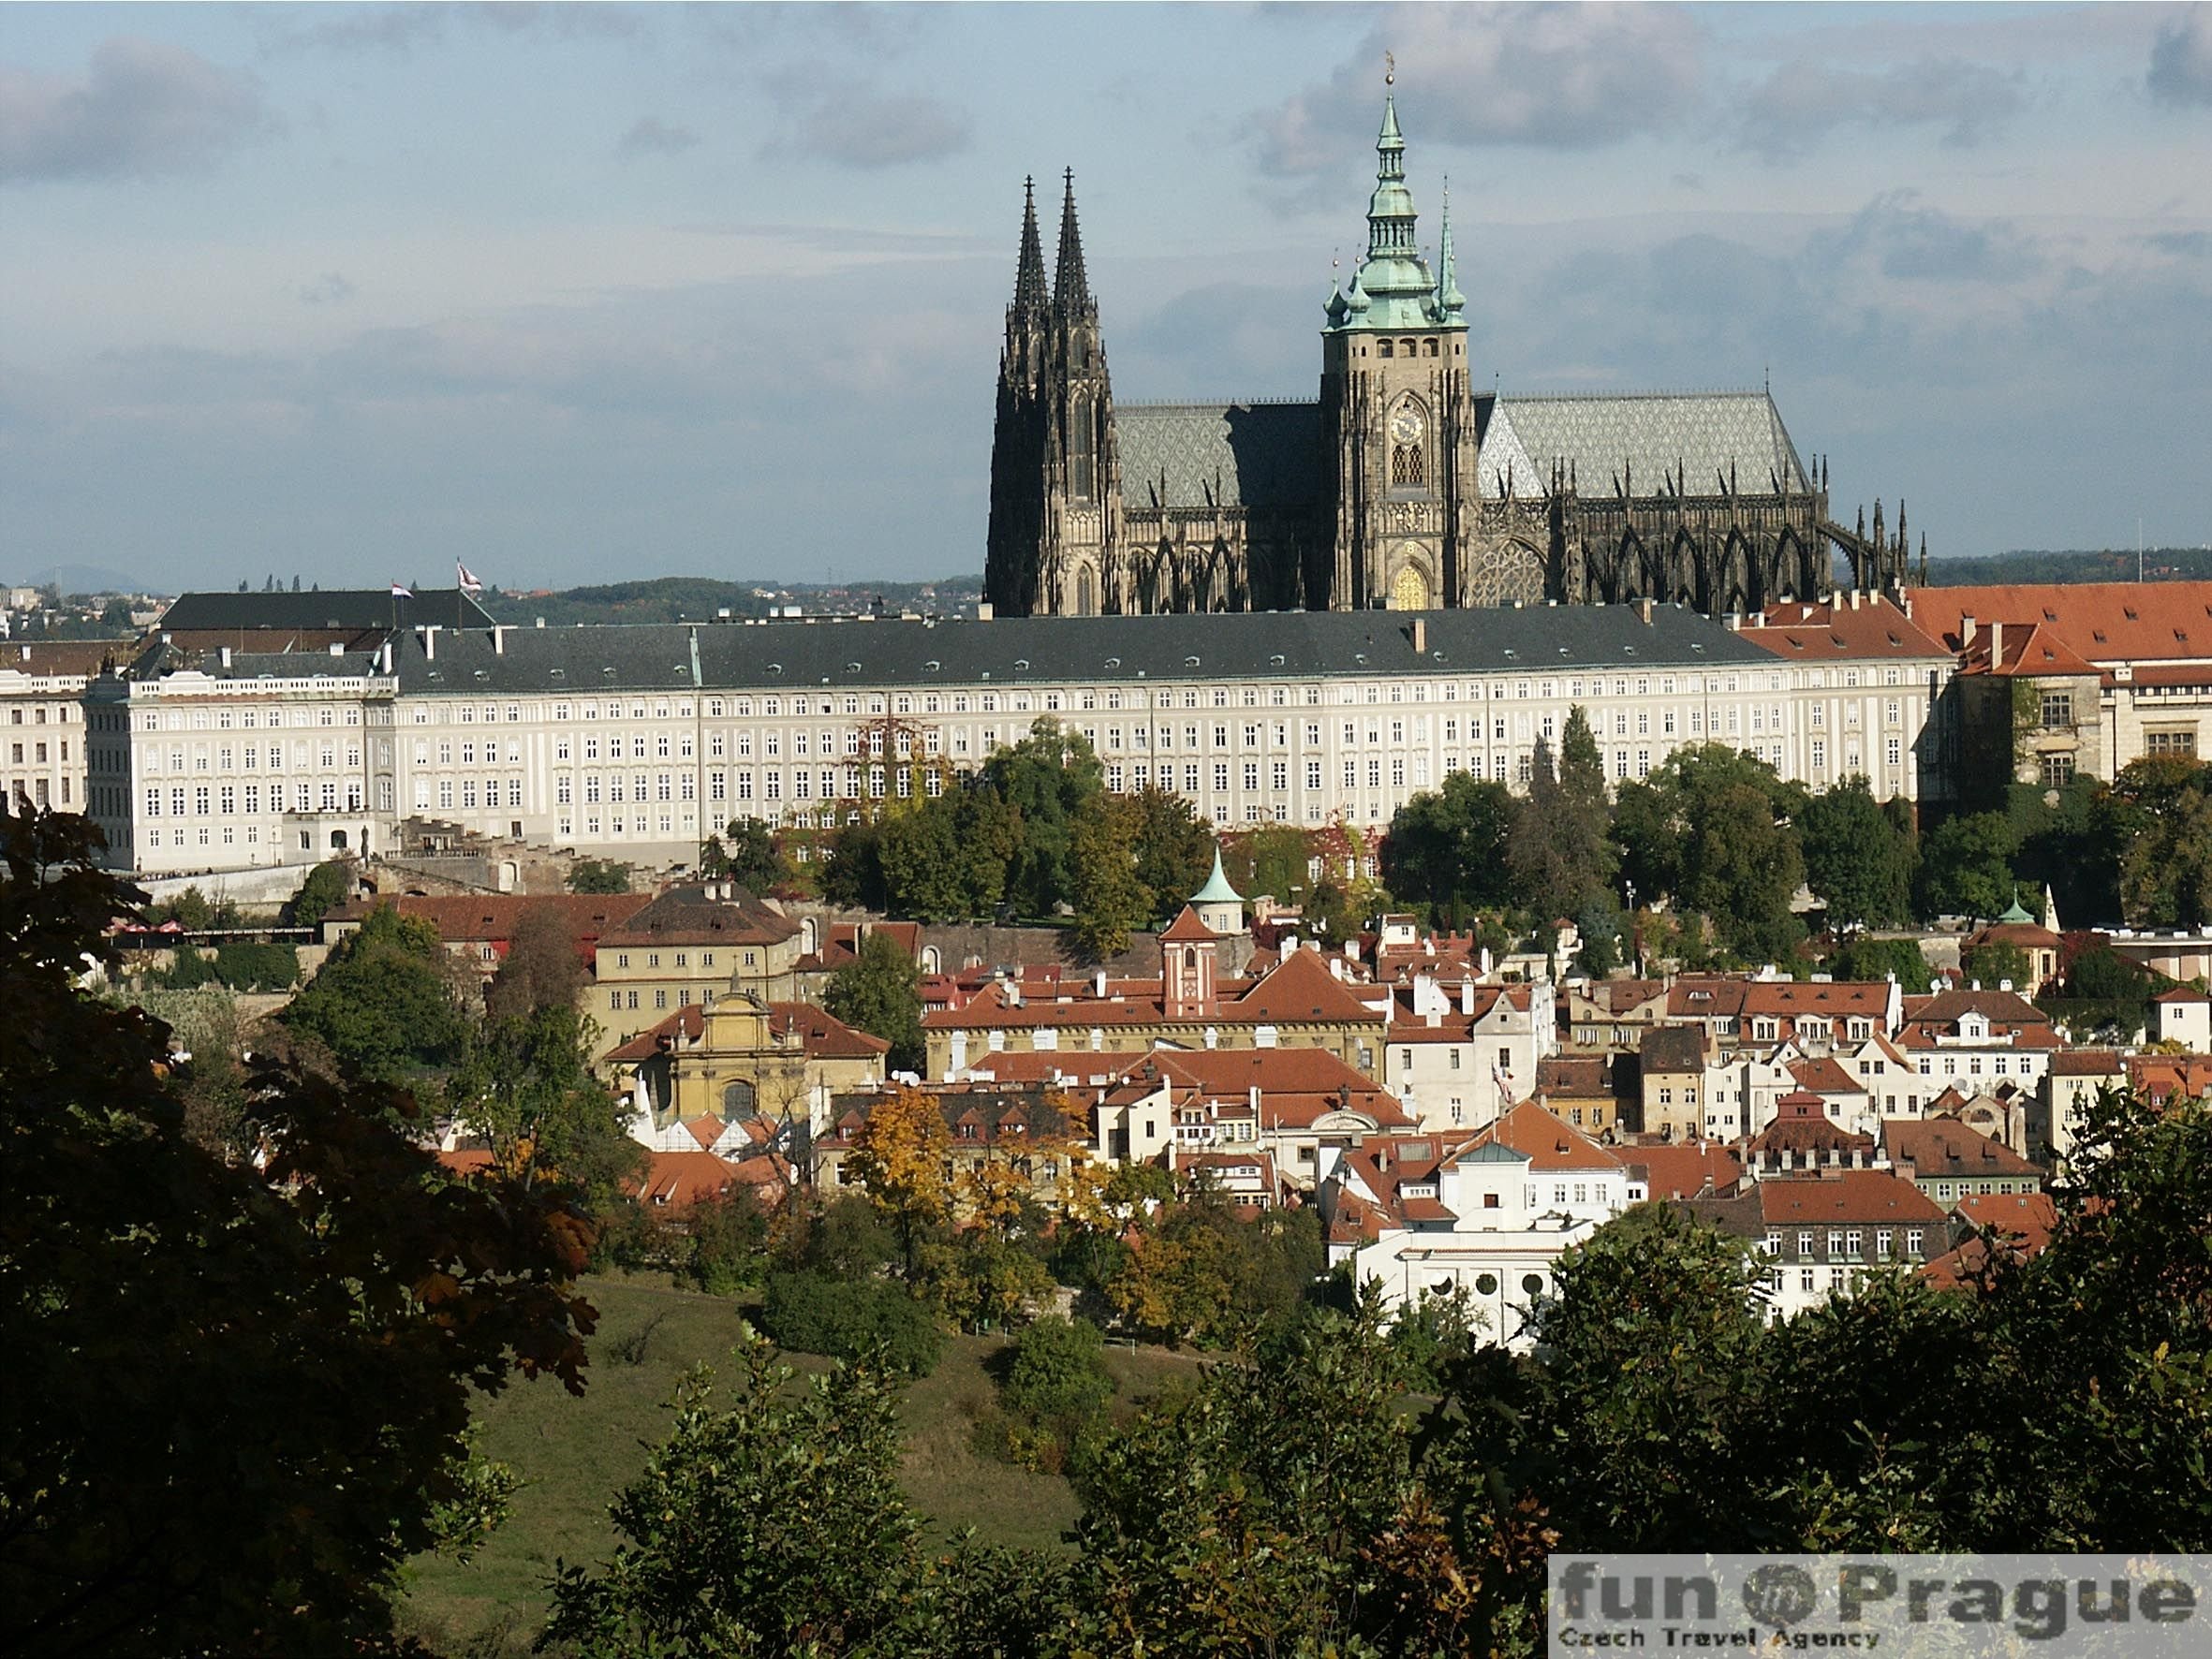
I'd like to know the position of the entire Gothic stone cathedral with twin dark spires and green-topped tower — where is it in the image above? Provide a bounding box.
[984,97,1905,615]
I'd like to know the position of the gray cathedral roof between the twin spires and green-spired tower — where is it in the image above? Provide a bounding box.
[1113,403,1325,511]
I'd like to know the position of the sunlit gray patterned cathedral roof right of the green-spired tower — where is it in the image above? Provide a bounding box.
[1475,391,1811,500]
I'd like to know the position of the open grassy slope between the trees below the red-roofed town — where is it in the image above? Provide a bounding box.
[389,1276,1197,1659]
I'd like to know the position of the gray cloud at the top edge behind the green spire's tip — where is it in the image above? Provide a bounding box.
[1257,5,1703,175]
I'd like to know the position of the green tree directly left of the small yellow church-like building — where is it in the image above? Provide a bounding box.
[447,1002,646,1214]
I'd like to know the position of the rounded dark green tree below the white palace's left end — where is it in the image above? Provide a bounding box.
[279,904,466,1081]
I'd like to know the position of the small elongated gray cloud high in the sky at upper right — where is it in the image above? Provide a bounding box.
[1736,57,2027,161]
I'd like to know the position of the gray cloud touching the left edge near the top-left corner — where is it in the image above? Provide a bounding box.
[0,36,276,184]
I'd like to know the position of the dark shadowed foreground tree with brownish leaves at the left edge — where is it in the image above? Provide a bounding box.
[0,814,593,1654]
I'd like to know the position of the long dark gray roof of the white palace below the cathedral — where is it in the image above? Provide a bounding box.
[376,606,1774,697]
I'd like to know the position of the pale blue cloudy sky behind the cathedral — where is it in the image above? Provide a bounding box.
[0,5,2212,588]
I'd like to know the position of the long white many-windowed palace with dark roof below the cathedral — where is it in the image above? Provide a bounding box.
[81,595,1951,876]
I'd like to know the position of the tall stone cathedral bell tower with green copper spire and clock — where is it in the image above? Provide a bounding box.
[1307,73,1475,610]
